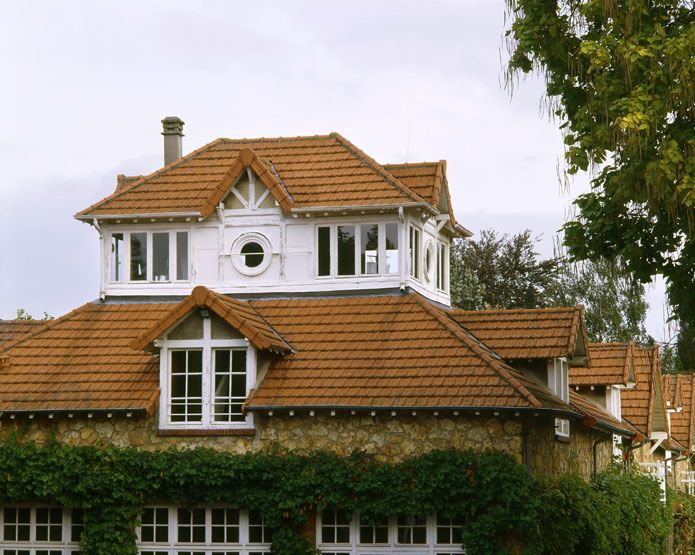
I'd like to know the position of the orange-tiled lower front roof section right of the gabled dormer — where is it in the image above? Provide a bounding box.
[247,294,580,411]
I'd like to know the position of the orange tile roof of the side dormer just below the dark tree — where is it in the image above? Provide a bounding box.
[450,305,588,360]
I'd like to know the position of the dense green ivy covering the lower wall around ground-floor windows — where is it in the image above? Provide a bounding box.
[0,438,684,555]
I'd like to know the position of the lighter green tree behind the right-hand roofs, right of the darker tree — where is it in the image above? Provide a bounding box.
[549,258,653,344]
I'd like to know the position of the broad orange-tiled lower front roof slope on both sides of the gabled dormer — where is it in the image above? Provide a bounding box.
[0,290,579,417]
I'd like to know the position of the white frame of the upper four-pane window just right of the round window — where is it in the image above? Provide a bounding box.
[313,221,403,280]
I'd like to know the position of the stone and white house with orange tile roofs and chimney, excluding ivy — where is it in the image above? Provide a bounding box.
[0,118,640,554]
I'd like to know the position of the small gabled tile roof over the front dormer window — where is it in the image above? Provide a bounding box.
[131,285,292,353]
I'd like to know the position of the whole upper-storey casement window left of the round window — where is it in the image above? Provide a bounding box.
[109,230,190,283]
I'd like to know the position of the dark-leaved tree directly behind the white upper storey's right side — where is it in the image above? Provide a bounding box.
[451,229,557,310]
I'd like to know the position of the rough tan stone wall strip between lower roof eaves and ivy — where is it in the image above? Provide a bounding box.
[0,413,611,478]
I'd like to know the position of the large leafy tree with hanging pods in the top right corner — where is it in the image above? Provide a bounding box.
[507,0,695,326]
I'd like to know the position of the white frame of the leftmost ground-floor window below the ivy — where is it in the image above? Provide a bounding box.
[0,503,80,555]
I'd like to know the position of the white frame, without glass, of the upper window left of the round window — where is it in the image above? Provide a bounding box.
[105,227,192,285]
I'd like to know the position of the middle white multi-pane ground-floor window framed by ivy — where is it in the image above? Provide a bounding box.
[137,506,272,555]
